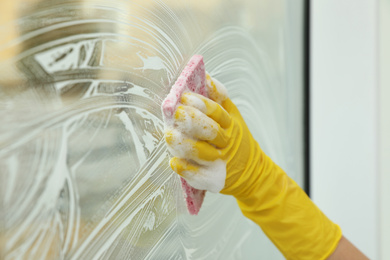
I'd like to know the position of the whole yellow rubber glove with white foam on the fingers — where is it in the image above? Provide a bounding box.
[165,75,342,260]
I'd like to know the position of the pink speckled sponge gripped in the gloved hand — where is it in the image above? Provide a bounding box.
[161,55,207,215]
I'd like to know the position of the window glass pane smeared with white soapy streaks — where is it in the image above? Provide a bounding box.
[0,0,303,259]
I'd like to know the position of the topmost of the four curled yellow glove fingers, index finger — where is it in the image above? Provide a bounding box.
[181,92,232,128]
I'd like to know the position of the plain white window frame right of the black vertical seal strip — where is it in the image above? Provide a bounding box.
[310,0,390,259]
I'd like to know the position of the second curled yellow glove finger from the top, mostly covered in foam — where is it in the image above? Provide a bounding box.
[174,106,228,148]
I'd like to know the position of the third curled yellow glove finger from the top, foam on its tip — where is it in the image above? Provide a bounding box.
[165,128,221,164]
